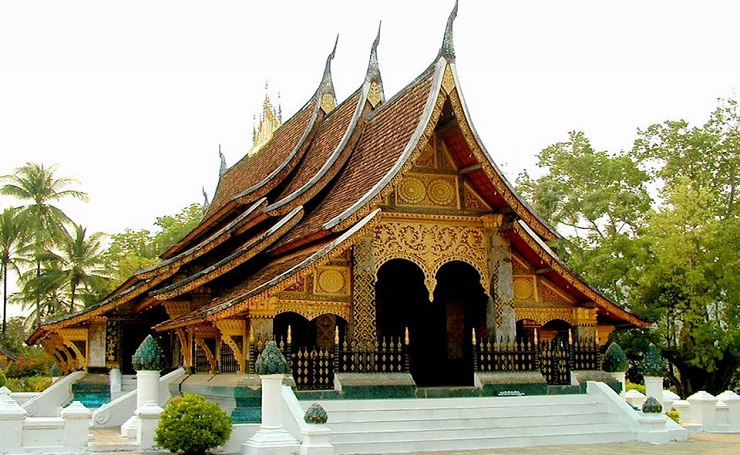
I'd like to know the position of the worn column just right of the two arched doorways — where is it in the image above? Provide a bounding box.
[481,214,516,340]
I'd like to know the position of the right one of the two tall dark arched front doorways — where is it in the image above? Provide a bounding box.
[425,261,488,386]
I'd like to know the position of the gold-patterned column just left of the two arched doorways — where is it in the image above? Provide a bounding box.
[348,237,378,346]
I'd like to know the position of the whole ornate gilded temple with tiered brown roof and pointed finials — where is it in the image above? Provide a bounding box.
[28,2,647,396]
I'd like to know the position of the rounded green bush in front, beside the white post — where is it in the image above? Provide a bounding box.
[154,394,232,455]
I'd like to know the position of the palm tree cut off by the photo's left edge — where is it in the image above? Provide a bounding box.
[0,208,31,334]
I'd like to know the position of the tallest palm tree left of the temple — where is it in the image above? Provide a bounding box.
[0,163,87,325]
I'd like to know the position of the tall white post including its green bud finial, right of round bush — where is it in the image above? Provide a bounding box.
[242,341,298,455]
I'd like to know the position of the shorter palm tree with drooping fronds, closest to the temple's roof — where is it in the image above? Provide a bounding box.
[33,223,108,313]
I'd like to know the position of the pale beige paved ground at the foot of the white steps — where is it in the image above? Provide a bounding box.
[90,430,740,455]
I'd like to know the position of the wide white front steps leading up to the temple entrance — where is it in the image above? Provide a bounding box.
[301,394,636,454]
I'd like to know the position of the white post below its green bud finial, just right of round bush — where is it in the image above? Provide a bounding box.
[242,373,298,455]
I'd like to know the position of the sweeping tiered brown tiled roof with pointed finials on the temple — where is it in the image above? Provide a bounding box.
[29,5,645,342]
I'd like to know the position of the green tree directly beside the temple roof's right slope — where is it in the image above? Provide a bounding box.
[517,132,650,303]
